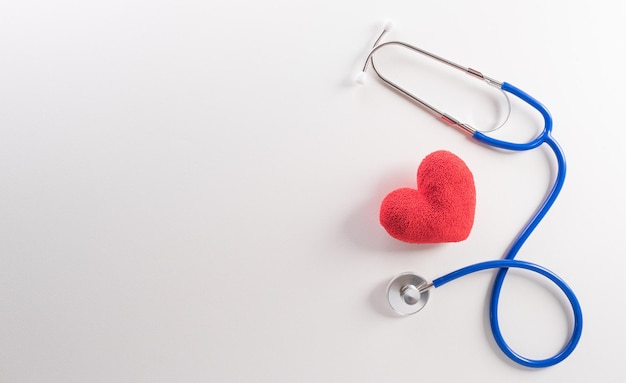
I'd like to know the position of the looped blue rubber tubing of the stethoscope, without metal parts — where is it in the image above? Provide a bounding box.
[432,82,583,368]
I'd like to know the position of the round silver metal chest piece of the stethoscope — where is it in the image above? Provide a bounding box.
[387,273,432,315]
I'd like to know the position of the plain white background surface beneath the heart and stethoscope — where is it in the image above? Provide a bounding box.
[0,0,626,382]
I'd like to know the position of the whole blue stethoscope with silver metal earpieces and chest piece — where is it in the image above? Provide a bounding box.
[356,23,583,368]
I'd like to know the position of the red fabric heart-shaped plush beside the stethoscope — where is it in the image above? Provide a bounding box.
[380,150,476,243]
